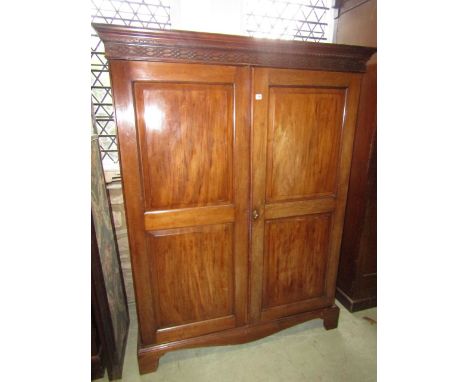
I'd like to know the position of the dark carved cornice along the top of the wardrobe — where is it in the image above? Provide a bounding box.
[93,24,377,72]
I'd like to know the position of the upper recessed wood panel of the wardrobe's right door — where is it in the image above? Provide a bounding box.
[266,85,346,202]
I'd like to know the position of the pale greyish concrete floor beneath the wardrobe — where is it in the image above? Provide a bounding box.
[96,302,377,382]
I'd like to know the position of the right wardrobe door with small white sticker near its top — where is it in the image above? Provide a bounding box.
[251,68,361,321]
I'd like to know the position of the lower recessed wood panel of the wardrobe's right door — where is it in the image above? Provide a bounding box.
[262,214,331,310]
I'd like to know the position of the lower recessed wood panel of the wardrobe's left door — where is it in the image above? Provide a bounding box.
[149,224,235,328]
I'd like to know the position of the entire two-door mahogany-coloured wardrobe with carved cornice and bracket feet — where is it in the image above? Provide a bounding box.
[95,25,374,373]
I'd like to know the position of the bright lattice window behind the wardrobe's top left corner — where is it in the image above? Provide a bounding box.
[91,0,171,169]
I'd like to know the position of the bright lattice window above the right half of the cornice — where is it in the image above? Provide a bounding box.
[244,0,332,42]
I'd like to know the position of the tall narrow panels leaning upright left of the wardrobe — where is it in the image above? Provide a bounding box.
[91,128,130,380]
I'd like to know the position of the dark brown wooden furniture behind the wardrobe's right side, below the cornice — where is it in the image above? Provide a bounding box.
[336,64,377,312]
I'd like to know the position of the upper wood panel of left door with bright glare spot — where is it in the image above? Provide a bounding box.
[134,82,234,210]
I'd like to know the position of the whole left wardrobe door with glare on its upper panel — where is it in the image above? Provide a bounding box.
[110,60,250,345]
